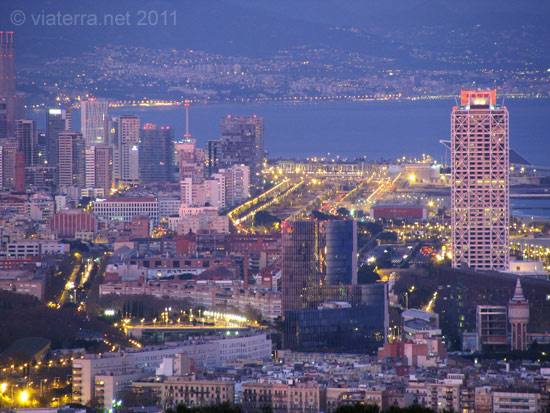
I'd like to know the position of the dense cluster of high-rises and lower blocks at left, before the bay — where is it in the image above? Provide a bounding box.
[0,32,265,272]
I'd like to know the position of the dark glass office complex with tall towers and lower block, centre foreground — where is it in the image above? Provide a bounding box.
[281,219,389,351]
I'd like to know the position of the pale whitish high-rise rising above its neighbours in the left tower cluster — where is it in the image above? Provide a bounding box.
[80,98,108,146]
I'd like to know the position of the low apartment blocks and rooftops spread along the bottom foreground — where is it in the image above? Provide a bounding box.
[73,340,550,413]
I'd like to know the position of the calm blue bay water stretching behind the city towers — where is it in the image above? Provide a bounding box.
[32,99,550,165]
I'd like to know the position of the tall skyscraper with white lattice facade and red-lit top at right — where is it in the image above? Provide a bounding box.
[451,89,510,271]
